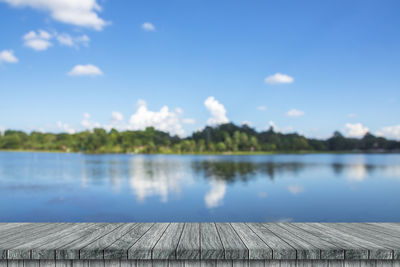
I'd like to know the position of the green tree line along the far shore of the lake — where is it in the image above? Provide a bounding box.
[0,123,400,154]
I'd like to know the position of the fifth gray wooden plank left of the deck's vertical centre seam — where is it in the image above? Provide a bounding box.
[79,223,136,259]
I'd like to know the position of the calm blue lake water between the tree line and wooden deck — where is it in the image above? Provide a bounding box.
[0,152,400,222]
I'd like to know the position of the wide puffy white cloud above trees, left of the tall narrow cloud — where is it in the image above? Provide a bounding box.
[128,100,185,136]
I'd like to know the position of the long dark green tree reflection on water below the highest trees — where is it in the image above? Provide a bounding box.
[192,160,306,183]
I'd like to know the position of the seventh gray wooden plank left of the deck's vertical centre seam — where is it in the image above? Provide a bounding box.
[31,223,106,260]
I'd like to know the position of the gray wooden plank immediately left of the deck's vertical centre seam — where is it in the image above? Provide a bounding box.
[176,223,201,260]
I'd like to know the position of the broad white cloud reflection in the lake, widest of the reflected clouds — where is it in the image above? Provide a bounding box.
[129,156,190,202]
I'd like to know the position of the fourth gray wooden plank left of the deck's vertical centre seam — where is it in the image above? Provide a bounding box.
[104,223,154,259]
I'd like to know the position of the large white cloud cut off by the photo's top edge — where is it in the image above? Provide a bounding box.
[0,0,108,30]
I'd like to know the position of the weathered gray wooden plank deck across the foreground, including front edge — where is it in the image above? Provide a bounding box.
[0,223,400,262]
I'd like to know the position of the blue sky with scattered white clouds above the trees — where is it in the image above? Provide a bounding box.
[0,0,400,139]
